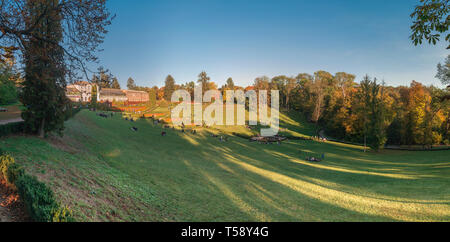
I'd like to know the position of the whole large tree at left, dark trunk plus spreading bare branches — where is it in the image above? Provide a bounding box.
[0,0,112,136]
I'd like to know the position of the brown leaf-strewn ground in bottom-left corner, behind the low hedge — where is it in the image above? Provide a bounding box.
[0,181,30,222]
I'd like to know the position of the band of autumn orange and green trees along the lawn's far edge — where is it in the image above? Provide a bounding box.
[146,71,450,149]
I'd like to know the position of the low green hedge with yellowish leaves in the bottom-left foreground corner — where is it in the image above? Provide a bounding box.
[0,150,74,222]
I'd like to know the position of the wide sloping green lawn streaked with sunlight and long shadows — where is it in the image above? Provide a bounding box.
[0,110,450,221]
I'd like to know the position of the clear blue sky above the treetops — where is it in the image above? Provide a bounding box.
[94,0,450,88]
